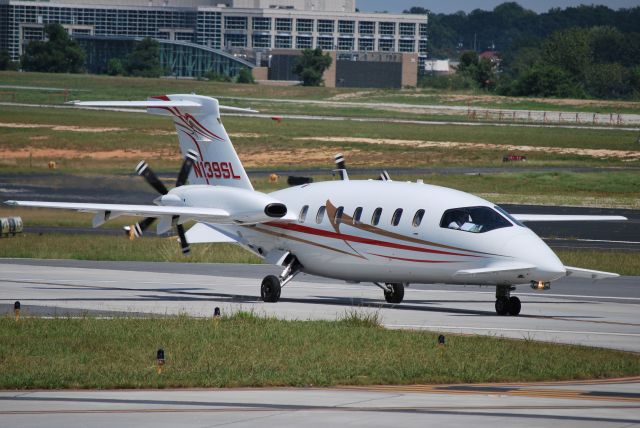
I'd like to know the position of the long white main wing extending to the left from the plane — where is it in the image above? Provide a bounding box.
[5,201,232,227]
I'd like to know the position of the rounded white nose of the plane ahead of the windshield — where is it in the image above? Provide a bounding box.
[504,231,566,282]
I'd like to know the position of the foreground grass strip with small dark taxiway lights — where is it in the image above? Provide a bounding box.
[0,310,640,389]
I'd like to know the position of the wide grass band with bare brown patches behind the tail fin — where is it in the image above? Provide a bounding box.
[0,103,639,173]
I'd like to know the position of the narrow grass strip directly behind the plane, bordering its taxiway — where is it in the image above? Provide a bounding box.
[0,233,640,276]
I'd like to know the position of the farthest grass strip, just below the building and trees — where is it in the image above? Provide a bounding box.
[0,71,640,113]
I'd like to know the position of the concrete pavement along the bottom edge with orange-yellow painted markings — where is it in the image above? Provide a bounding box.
[0,378,640,428]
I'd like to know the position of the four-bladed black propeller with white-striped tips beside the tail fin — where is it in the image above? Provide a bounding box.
[124,150,198,254]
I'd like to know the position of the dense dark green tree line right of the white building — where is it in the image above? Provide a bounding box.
[405,2,640,99]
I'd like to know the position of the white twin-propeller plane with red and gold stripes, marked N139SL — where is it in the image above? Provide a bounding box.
[7,95,626,315]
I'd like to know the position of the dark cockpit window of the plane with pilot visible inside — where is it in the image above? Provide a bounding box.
[440,207,513,233]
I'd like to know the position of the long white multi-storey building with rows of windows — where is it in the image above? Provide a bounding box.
[0,0,427,69]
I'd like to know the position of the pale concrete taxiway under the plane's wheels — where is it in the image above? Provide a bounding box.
[0,260,640,352]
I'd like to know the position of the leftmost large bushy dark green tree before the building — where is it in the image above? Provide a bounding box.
[21,24,85,73]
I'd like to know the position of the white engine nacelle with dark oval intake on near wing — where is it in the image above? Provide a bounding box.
[170,185,287,223]
